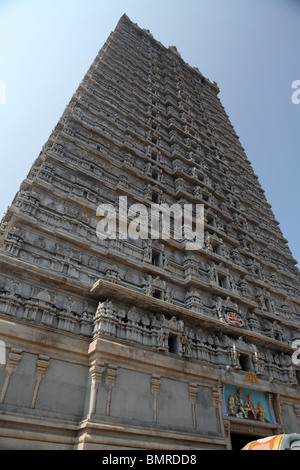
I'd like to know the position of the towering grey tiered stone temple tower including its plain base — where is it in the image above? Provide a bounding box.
[0,15,300,450]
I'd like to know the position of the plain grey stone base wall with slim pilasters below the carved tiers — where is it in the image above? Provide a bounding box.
[0,319,300,450]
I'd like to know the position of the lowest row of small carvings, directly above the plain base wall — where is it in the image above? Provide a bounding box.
[94,300,296,383]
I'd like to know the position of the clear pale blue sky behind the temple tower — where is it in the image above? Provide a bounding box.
[0,0,300,260]
